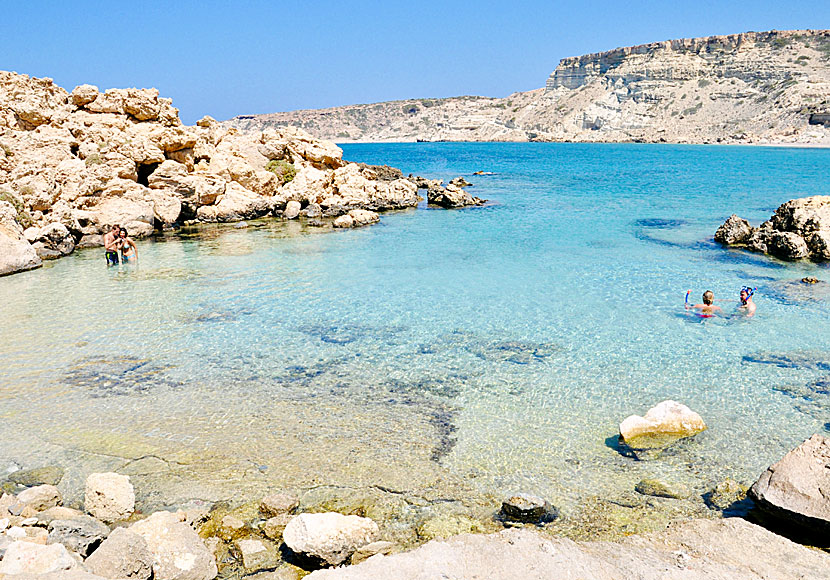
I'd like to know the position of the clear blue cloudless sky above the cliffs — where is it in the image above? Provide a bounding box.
[0,0,830,123]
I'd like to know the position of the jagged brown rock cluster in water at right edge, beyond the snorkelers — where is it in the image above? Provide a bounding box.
[715,195,830,261]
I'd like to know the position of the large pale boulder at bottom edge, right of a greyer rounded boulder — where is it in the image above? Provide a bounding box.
[129,512,217,580]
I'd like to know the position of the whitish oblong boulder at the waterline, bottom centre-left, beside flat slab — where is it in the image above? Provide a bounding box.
[282,512,379,566]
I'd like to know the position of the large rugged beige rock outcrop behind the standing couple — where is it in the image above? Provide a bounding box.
[0,71,488,275]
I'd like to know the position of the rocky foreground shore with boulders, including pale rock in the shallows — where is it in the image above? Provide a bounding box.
[0,401,830,580]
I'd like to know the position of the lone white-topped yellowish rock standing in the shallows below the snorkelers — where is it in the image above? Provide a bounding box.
[620,401,706,457]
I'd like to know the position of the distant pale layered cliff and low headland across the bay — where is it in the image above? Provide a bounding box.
[227,30,830,144]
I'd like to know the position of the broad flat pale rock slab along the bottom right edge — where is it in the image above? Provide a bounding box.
[306,518,830,580]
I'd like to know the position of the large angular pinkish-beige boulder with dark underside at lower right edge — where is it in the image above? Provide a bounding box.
[749,435,830,538]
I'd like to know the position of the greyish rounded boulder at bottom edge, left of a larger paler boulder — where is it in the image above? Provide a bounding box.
[84,528,154,580]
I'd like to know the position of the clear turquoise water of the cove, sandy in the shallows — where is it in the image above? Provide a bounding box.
[0,144,830,511]
